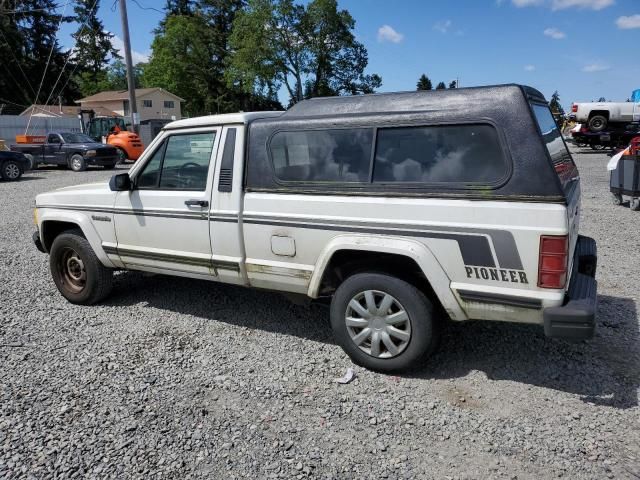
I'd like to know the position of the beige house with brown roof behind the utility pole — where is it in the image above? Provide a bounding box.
[76,88,184,122]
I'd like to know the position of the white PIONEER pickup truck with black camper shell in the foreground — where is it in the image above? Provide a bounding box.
[34,85,597,371]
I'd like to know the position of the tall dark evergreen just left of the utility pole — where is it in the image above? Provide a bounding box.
[72,0,121,96]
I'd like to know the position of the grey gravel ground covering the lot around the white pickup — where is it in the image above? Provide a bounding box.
[0,151,640,479]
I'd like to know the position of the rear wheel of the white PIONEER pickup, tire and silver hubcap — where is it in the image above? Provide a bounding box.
[331,273,439,372]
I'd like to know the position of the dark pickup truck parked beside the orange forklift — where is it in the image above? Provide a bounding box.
[11,132,118,172]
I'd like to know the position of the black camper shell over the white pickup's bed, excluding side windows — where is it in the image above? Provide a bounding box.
[245,85,577,203]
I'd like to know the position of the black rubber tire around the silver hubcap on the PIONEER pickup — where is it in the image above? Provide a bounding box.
[331,273,440,372]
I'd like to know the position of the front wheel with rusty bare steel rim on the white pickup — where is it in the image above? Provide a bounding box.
[49,229,113,305]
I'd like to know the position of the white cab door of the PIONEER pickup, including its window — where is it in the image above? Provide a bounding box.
[113,128,220,276]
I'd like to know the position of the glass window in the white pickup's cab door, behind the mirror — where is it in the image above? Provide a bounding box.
[137,132,216,191]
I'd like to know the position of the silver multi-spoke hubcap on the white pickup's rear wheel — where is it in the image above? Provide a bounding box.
[345,290,411,358]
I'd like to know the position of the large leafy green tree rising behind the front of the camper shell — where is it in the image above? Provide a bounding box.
[226,0,382,103]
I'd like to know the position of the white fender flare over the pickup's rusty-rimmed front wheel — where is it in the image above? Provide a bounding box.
[39,209,116,268]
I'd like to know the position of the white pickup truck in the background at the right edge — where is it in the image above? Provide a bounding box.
[571,98,640,132]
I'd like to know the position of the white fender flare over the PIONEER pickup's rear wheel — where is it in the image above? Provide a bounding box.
[307,234,467,320]
